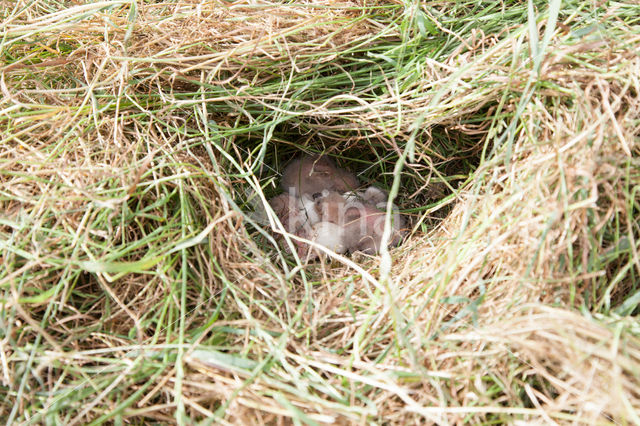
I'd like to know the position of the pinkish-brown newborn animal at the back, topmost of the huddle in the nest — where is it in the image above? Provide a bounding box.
[280,155,359,196]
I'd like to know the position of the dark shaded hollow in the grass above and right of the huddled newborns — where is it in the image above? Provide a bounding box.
[242,121,485,258]
